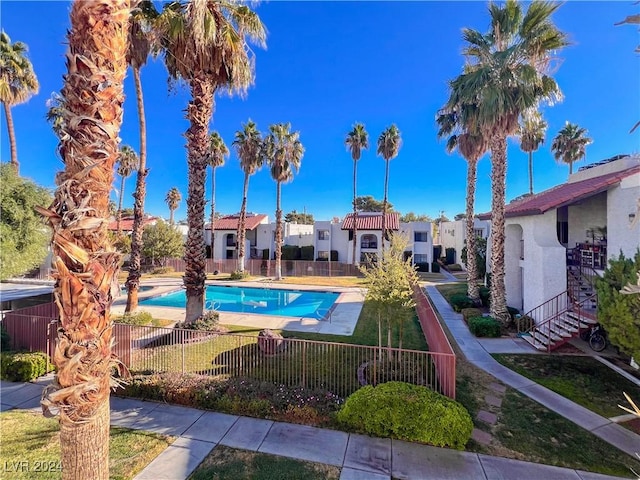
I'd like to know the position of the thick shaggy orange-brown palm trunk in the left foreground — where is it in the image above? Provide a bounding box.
[39,0,130,480]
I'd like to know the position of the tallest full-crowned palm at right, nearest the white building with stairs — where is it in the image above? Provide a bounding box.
[447,0,568,323]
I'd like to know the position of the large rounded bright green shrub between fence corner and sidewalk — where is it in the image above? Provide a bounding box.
[337,382,473,450]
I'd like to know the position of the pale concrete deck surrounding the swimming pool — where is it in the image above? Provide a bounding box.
[111,278,366,335]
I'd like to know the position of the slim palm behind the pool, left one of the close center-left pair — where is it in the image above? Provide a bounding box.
[233,119,264,272]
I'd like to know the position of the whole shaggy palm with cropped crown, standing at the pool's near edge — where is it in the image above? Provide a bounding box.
[158,0,266,322]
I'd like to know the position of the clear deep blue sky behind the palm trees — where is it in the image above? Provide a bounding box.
[0,0,640,220]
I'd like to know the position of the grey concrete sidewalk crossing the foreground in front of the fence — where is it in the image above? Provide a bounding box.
[0,381,632,480]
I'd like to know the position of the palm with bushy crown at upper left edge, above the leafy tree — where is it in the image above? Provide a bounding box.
[0,32,40,172]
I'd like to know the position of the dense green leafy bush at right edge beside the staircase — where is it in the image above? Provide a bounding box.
[596,249,640,359]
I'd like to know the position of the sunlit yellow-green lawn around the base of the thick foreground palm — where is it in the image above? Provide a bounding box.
[0,410,174,480]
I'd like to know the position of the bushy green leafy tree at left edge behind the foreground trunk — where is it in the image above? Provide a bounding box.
[0,163,51,280]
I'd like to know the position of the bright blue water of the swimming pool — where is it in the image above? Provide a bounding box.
[140,286,339,319]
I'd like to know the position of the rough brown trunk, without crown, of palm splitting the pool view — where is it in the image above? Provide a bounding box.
[184,75,214,322]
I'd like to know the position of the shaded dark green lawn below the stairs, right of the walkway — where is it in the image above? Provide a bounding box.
[493,354,640,418]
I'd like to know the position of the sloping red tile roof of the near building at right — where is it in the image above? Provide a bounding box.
[478,166,640,220]
